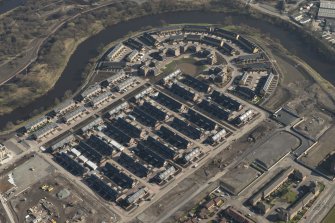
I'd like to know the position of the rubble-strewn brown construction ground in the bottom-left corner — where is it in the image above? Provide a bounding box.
[10,175,111,223]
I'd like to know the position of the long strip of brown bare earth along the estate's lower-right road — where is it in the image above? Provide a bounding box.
[137,120,277,222]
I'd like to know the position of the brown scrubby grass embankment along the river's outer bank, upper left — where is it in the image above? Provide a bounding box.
[0,1,215,132]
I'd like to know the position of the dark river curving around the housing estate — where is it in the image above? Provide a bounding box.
[0,11,335,129]
